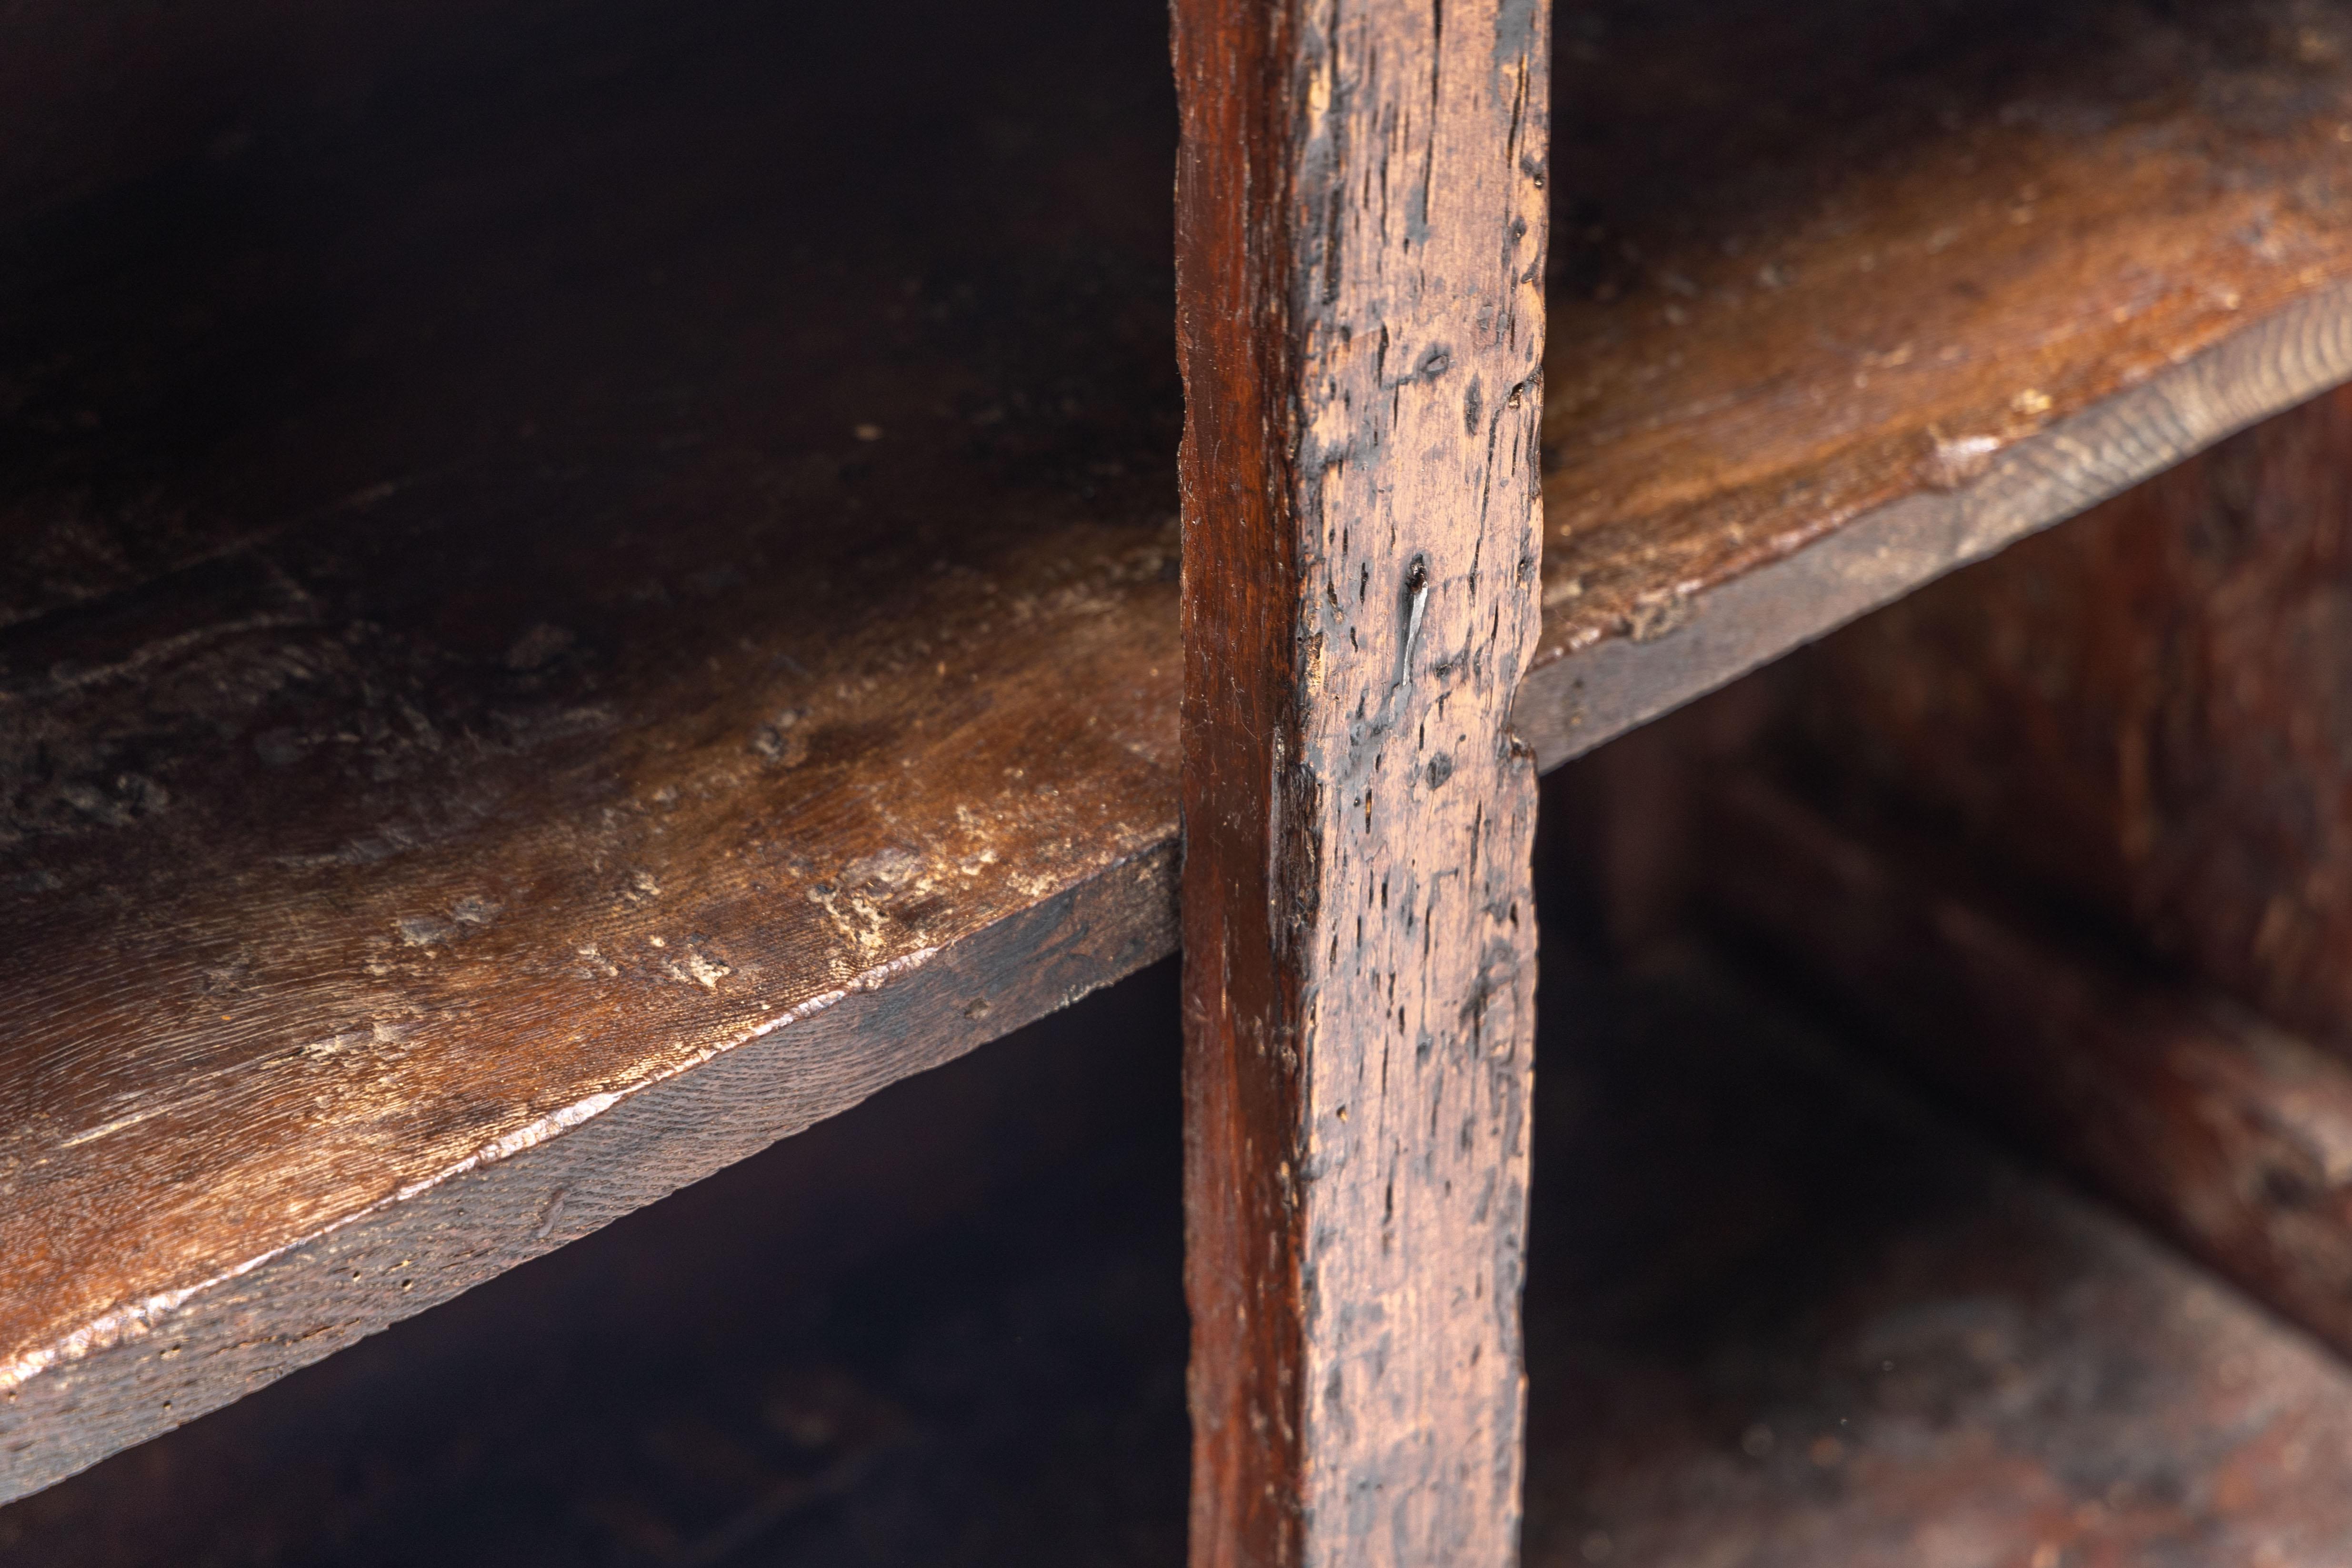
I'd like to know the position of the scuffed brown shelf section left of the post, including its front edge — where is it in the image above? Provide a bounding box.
[0,7,1178,1493]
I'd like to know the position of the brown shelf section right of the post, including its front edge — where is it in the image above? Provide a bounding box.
[1520,0,2352,766]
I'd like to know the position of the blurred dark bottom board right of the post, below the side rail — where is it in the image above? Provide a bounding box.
[1526,952,2352,1568]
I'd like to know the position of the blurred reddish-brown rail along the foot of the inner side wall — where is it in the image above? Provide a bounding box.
[1703,780,2352,1382]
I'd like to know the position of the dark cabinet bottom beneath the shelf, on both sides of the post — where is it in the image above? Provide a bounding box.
[14,926,2352,1568]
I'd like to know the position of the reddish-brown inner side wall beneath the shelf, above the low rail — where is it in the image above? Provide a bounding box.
[1802,392,2352,1051]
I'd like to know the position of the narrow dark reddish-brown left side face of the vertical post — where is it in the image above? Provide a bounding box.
[1171,0,1305,1568]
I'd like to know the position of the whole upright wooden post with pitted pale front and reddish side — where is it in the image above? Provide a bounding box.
[1174,0,1550,1568]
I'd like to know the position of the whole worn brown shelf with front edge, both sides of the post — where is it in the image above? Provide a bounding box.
[14,2,2352,1490]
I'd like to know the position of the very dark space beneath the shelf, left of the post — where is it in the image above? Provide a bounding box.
[0,964,1188,1568]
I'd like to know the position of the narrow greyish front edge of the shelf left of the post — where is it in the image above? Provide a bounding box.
[0,860,1176,1502]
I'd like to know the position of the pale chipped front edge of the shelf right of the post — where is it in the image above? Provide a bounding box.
[1515,282,2352,769]
